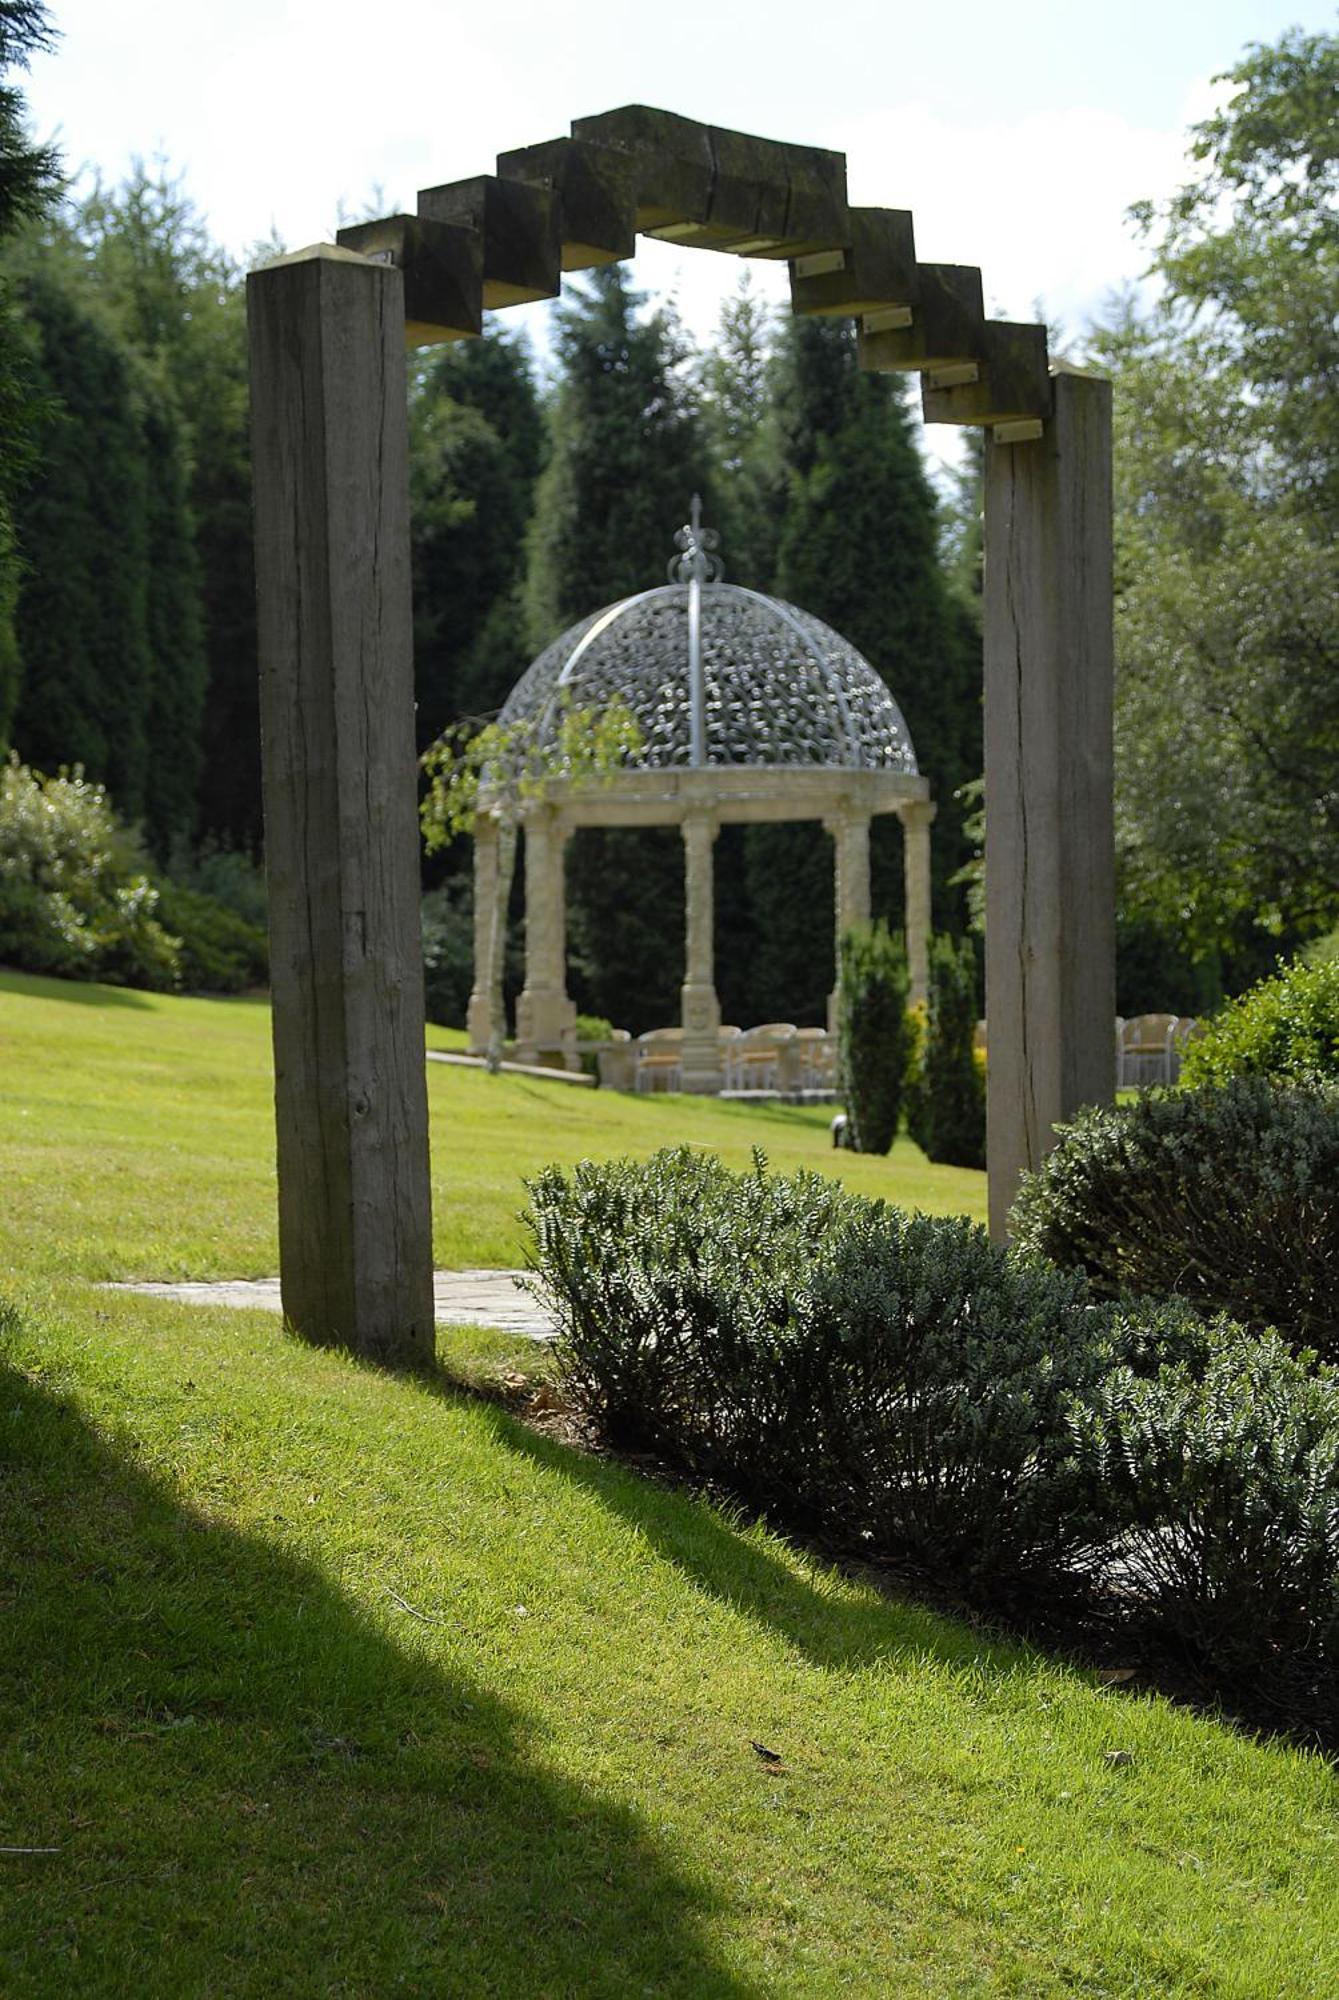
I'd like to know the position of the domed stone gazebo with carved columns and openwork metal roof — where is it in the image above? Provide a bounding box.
[470,500,935,1092]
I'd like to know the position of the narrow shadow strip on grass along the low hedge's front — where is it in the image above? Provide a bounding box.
[445,1376,1039,1678]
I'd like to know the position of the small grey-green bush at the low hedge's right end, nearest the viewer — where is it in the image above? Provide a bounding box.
[1071,1328,1339,1706]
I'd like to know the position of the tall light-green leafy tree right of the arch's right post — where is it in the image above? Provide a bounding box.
[1097,30,1339,958]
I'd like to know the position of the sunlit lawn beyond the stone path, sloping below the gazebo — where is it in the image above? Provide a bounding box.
[0,974,985,1278]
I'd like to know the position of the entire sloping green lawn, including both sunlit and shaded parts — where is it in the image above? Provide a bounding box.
[0,964,1339,2000]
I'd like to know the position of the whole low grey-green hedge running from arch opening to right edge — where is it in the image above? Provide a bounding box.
[528,1150,1339,1728]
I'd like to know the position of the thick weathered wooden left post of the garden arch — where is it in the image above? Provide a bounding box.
[248,244,434,1362]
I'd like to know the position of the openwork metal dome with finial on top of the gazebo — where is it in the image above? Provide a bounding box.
[500,500,917,776]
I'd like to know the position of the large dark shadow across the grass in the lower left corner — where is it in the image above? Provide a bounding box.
[0,1364,749,2000]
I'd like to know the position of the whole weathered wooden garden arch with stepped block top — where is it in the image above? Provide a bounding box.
[248,106,1115,1360]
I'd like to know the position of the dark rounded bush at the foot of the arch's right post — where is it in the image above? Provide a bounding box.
[1011,1076,1339,1358]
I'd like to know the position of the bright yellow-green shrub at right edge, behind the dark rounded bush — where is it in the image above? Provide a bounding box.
[1181,958,1339,1084]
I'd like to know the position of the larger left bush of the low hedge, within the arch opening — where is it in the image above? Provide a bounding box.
[530,1150,1203,1602]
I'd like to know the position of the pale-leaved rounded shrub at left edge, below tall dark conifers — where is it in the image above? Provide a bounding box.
[0,756,180,990]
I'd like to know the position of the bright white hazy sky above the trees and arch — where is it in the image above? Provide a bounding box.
[26,0,1335,382]
